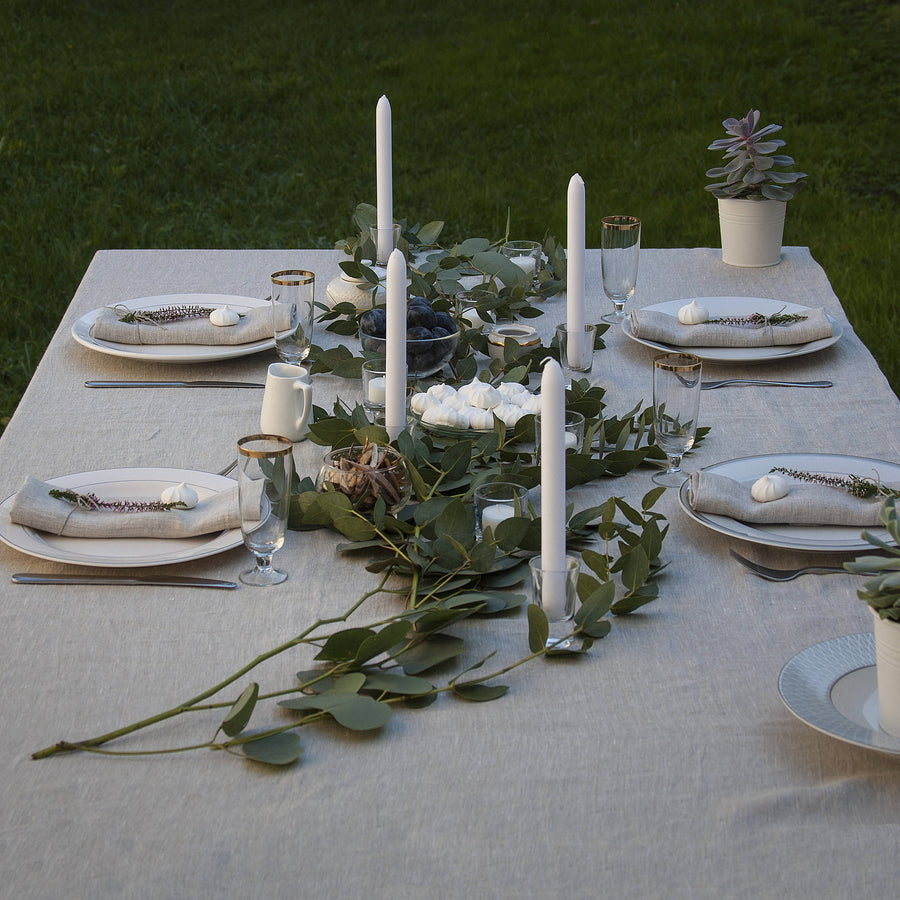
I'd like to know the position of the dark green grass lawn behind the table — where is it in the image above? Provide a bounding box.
[0,0,900,425]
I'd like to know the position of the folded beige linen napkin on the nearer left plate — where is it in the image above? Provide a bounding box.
[9,476,241,538]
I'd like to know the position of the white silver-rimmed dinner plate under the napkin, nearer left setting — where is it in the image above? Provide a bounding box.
[0,468,243,568]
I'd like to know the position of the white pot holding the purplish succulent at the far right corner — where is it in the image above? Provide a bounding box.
[719,198,787,266]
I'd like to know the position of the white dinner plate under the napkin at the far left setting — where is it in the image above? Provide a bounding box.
[72,294,275,363]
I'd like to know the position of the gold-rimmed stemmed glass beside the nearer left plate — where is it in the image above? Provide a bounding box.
[237,434,294,586]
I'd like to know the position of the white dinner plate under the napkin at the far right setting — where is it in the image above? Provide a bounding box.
[622,297,844,363]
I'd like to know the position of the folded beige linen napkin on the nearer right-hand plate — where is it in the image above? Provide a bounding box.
[688,471,882,528]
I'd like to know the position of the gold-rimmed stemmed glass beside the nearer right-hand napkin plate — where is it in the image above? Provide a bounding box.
[651,353,702,487]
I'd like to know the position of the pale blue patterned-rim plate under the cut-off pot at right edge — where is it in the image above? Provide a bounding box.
[778,632,900,755]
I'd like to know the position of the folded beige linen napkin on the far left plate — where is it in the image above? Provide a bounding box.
[91,303,294,346]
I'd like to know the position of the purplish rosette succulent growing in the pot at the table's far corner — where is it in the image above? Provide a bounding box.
[706,109,806,200]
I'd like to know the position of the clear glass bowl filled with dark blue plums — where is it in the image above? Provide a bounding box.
[359,297,459,378]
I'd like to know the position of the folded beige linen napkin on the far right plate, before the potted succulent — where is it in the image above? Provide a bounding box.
[631,307,834,347]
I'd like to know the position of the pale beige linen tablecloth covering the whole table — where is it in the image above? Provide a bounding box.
[0,248,900,898]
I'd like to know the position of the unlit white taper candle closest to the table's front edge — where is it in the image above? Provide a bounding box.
[541,359,566,620]
